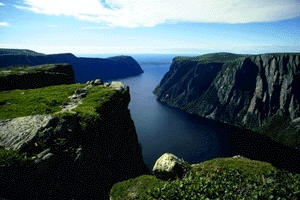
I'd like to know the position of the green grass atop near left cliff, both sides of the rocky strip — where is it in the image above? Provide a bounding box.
[0,84,114,120]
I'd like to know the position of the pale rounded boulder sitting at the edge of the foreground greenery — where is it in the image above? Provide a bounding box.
[152,153,185,180]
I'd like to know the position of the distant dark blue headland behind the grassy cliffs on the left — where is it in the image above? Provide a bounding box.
[0,49,143,83]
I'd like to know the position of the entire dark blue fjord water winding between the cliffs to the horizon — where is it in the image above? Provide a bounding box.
[108,55,300,172]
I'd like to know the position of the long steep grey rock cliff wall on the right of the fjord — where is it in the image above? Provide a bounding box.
[154,53,300,147]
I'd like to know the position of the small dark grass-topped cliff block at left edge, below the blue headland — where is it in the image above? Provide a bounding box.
[0,64,75,90]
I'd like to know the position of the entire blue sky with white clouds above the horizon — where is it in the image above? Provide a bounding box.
[0,0,300,54]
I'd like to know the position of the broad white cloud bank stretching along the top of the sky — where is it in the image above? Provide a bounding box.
[16,0,300,27]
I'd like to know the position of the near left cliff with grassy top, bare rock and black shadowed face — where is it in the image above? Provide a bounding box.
[0,81,149,199]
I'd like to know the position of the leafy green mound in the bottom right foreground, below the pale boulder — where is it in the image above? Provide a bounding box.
[110,158,300,199]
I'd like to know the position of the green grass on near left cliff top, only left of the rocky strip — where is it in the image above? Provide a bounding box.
[0,84,82,119]
